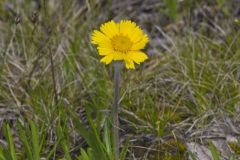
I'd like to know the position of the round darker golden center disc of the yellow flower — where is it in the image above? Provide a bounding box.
[111,34,133,52]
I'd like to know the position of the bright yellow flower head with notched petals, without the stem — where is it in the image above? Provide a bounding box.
[91,20,148,69]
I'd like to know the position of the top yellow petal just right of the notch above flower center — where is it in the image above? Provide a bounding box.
[119,20,137,36]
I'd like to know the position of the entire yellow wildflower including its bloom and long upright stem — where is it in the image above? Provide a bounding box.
[91,20,149,160]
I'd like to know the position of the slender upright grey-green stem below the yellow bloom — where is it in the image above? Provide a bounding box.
[112,62,121,160]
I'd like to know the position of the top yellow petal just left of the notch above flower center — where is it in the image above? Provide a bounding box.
[100,20,119,39]
